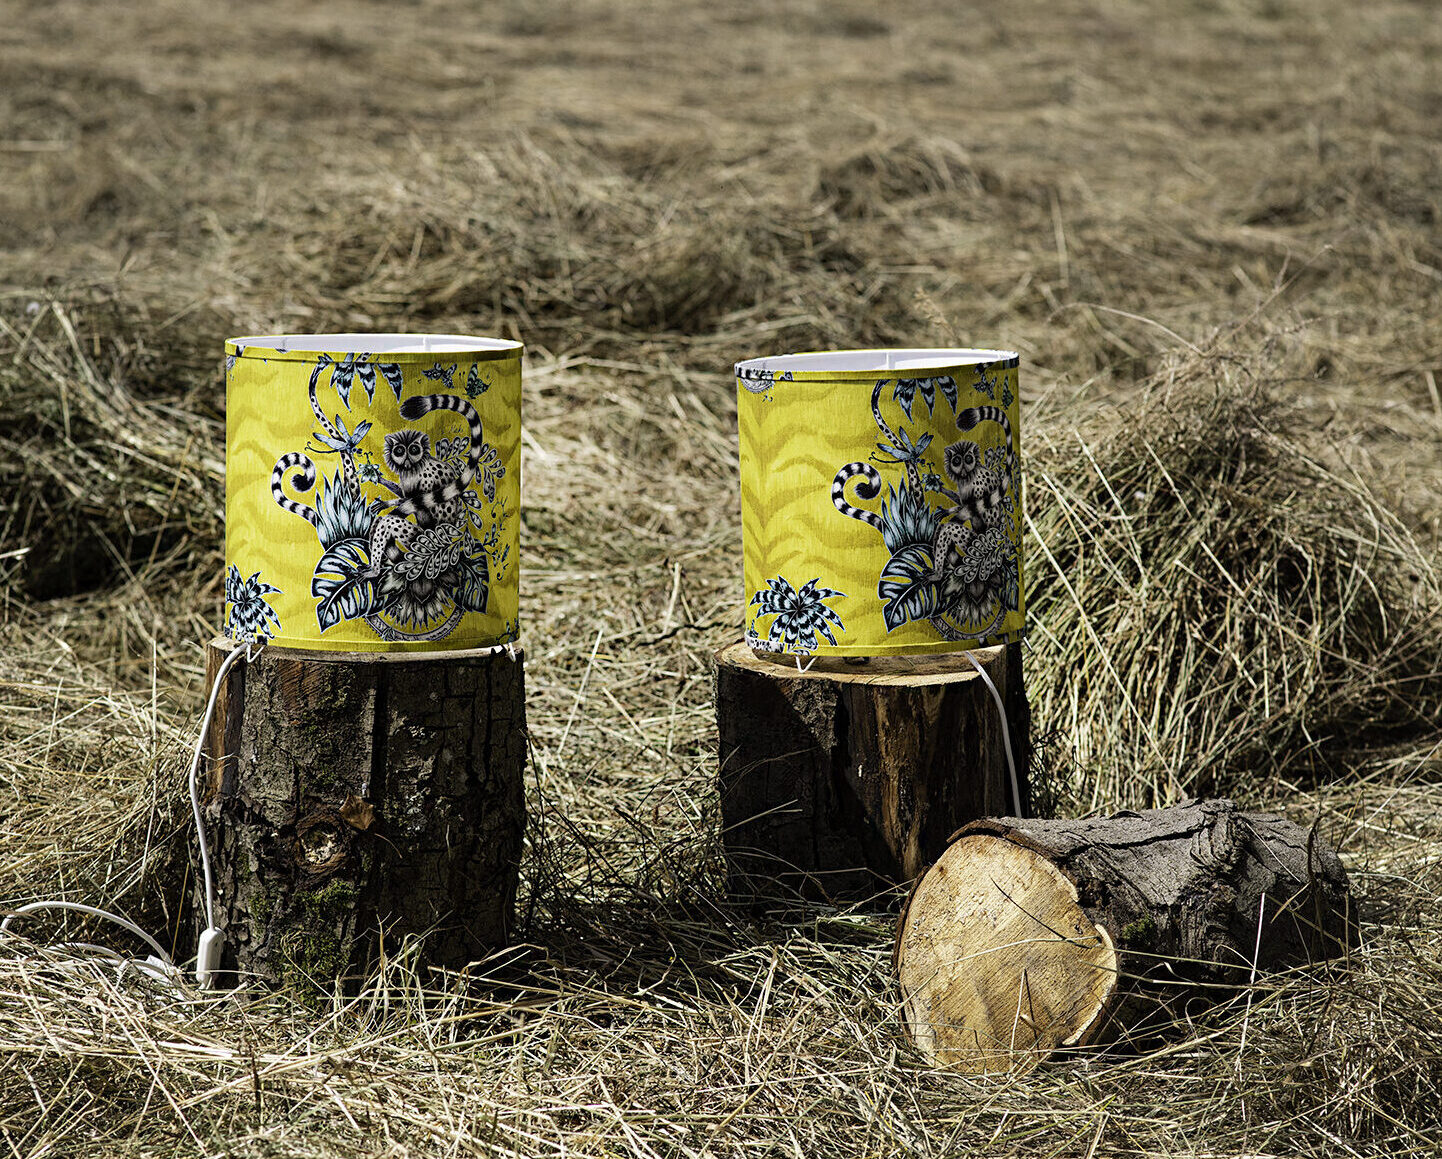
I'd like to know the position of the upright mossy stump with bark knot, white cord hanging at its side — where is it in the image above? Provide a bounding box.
[199,639,526,986]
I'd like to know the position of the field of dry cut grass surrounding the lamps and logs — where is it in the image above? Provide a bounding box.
[0,0,1442,1159]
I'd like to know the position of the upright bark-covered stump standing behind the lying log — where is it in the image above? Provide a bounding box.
[717,643,1030,900]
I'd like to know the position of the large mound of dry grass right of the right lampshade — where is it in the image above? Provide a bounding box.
[1027,334,1442,810]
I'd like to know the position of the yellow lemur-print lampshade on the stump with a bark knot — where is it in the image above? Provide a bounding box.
[224,334,522,652]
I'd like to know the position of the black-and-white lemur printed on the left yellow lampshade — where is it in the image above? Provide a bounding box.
[362,395,485,580]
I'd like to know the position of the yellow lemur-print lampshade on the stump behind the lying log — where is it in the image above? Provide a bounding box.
[735,350,1027,656]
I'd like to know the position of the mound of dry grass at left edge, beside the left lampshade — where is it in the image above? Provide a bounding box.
[0,290,224,600]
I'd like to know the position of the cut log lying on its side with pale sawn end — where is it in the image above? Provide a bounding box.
[895,800,1354,1073]
